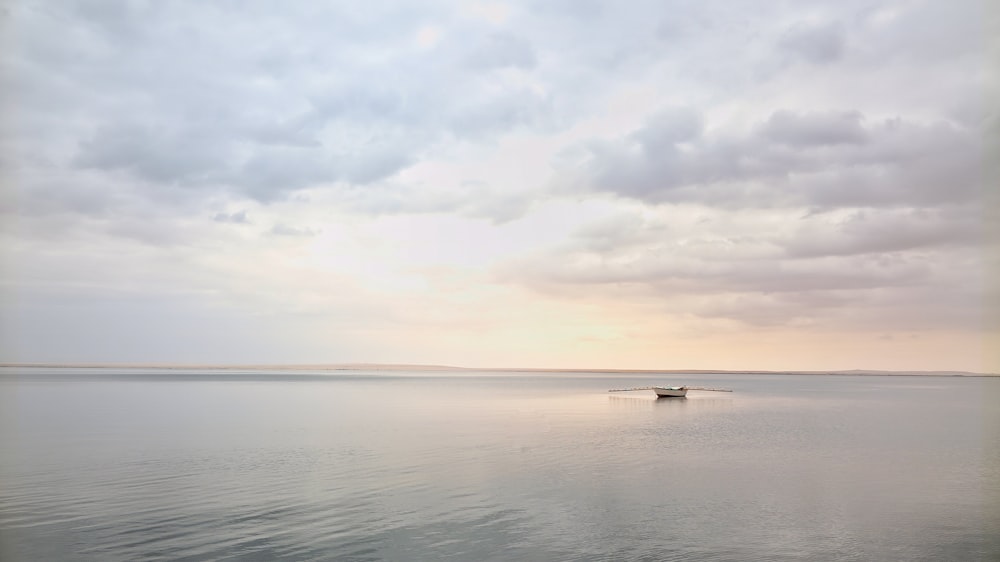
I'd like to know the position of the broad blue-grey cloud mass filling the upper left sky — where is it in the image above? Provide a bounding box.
[5,2,572,210]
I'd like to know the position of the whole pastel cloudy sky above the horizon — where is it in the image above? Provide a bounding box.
[0,0,1000,372]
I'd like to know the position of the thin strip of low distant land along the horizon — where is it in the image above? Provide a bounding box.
[0,363,1000,377]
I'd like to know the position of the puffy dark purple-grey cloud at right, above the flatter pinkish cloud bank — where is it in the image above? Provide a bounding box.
[560,110,979,208]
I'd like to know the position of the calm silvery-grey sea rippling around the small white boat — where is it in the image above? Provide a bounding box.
[0,368,1000,562]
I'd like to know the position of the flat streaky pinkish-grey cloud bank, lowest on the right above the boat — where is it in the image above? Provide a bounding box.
[496,206,983,330]
